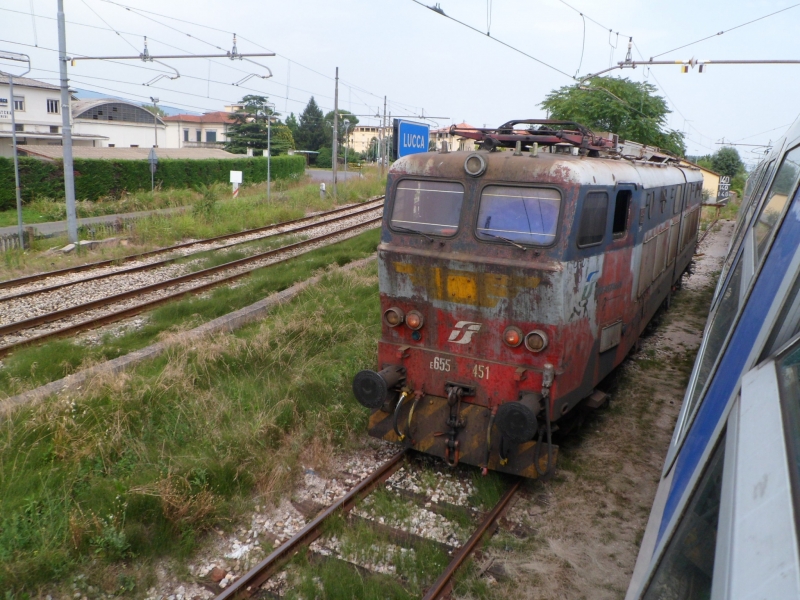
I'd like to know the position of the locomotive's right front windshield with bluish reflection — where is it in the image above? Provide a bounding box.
[477,185,561,246]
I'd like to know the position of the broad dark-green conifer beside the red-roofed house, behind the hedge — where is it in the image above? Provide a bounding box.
[225,95,294,156]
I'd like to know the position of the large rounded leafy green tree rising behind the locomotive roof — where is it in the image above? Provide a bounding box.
[539,77,686,156]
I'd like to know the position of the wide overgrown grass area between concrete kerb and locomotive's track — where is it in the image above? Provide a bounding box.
[0,254,388,598]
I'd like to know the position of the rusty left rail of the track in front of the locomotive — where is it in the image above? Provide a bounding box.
[216,450,407,600]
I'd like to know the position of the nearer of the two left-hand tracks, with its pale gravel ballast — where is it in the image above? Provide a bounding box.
[0,204,382,356]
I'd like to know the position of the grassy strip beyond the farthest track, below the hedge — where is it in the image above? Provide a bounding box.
[0,170,386,280]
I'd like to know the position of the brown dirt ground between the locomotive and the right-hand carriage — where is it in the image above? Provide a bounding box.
[464,221,734,600]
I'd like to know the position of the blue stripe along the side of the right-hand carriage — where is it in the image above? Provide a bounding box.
[656,191,800,546]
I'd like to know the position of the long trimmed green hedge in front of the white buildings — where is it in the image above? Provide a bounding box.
[0,156,306,210]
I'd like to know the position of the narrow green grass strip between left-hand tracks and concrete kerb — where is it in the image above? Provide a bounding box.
[0,229,380,396]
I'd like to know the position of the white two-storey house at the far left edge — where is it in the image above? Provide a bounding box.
[0,75,106,157]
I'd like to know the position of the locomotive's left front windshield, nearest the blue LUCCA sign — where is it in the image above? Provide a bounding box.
[391,179,464,237]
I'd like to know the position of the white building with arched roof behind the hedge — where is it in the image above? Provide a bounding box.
[70,98,167,148]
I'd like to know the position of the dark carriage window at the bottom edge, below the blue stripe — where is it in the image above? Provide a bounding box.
[643,434,725,600]
